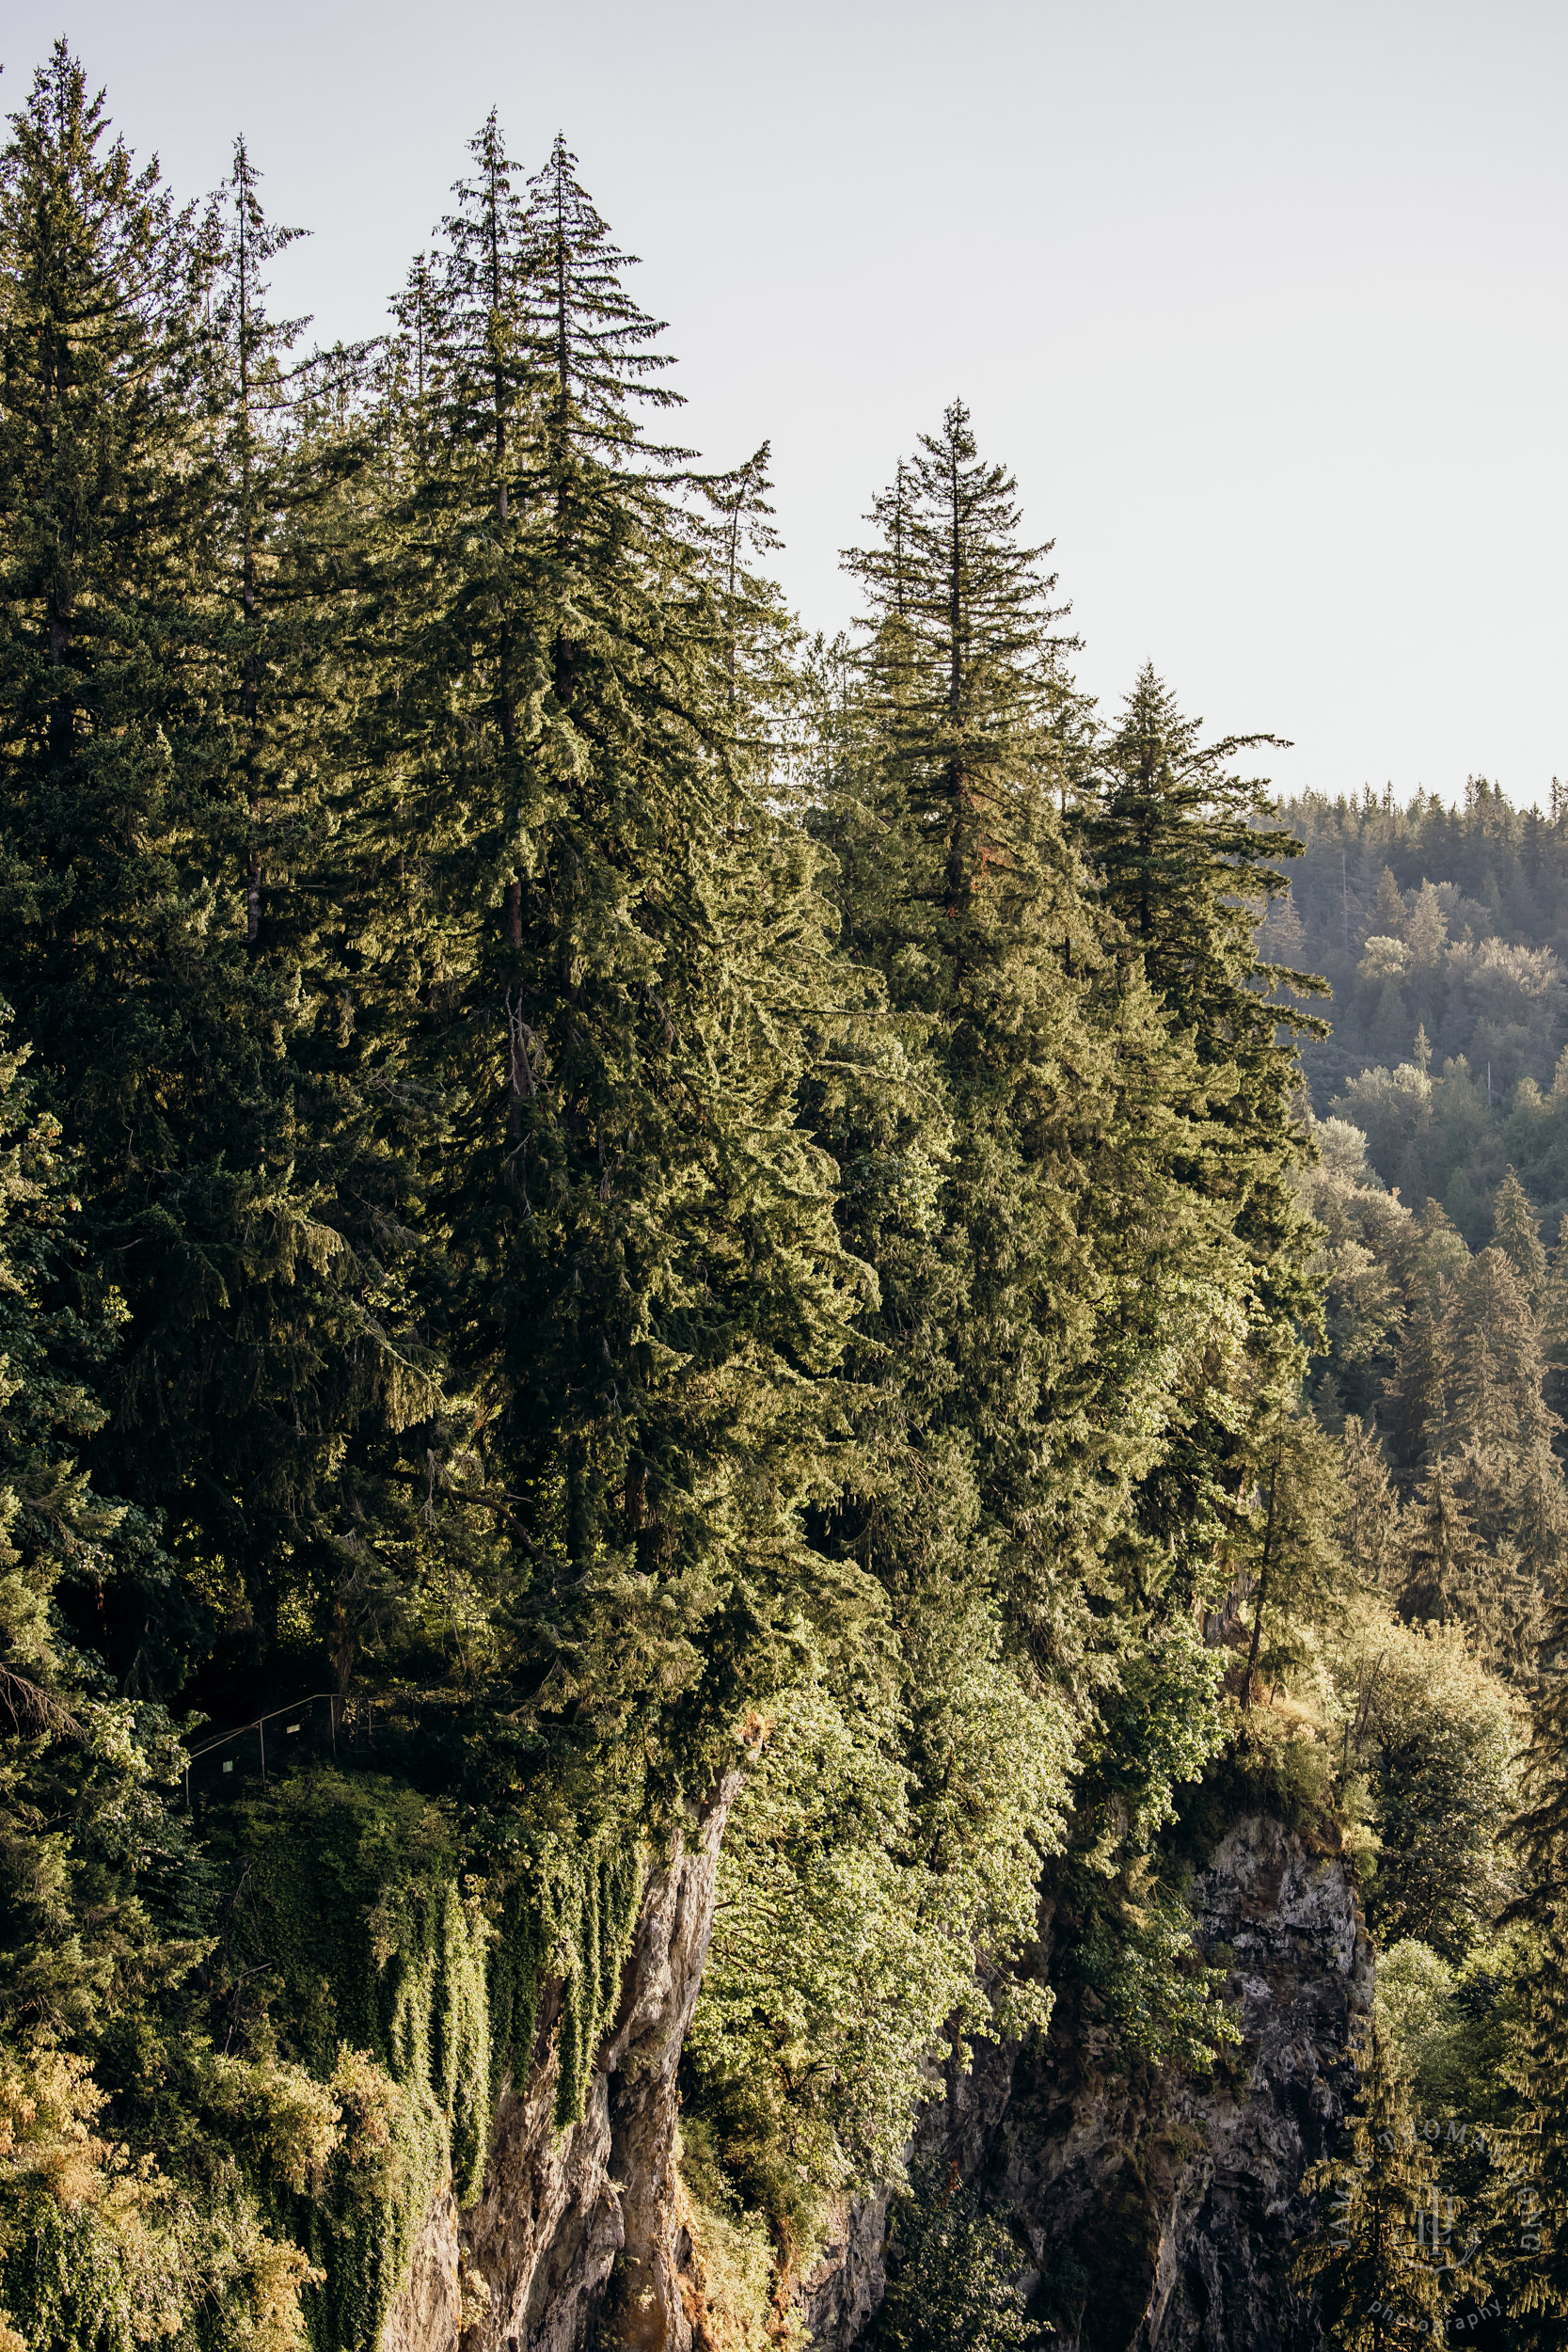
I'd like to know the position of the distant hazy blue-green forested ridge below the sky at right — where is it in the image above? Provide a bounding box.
[1260,779,1568,1245]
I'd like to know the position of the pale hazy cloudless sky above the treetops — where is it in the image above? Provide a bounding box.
[12,0,1568,800]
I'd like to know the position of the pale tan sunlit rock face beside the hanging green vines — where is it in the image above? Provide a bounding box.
[381,1772,740,2352]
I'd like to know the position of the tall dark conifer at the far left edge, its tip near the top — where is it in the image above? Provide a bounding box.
[0,42,226,1675]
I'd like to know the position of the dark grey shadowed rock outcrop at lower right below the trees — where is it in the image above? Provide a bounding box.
[806,1819,1373,2352]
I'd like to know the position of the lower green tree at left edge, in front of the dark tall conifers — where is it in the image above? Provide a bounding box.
[0,1002,202,2051]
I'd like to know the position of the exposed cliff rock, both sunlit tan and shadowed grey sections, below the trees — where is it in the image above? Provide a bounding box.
[383,1806,1373,2352]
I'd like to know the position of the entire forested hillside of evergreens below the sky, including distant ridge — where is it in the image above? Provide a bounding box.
[0,45,1568,2352]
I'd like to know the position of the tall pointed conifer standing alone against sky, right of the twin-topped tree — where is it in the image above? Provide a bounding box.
[820,403,1215,1661]
